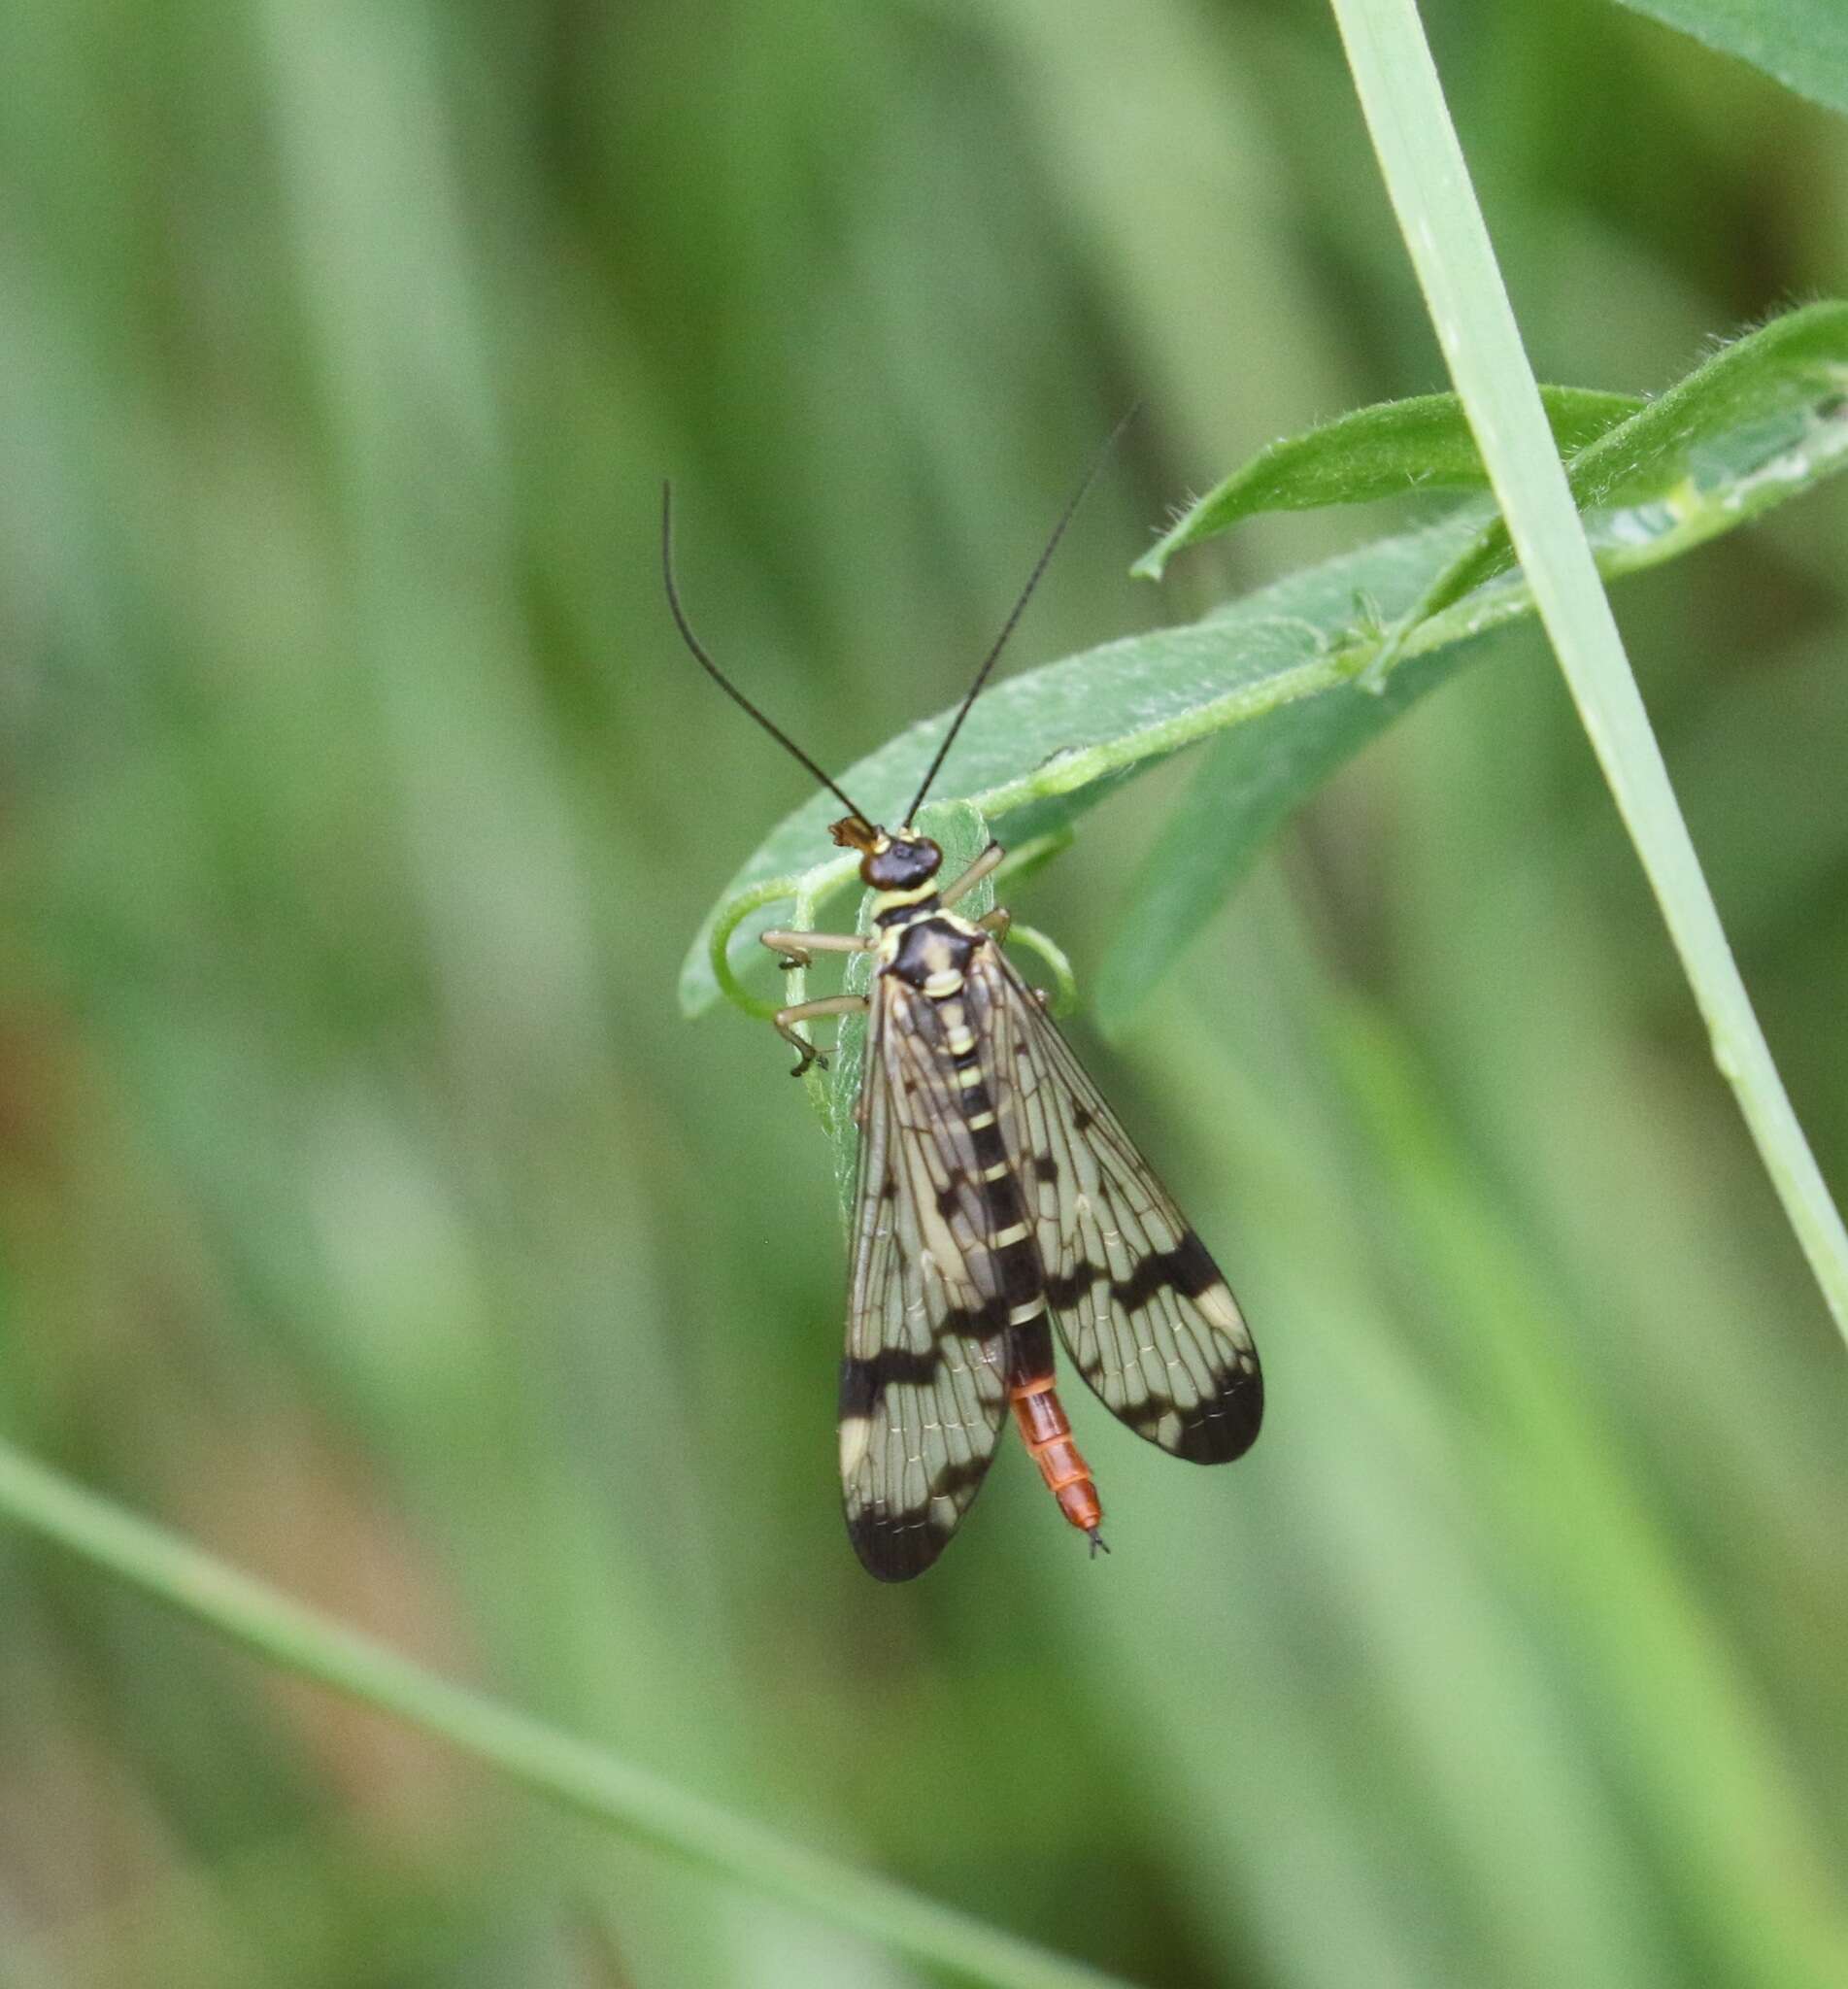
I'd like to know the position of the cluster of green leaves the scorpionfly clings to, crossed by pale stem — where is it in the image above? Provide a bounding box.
[681,304,1848,1025]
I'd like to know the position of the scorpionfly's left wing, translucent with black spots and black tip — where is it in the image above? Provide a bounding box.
[841,975,1007,1581]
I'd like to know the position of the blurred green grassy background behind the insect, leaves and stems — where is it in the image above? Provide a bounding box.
[0,0,1848,1989]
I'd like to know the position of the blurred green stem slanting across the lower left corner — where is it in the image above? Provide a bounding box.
[0,1442,1120,1989]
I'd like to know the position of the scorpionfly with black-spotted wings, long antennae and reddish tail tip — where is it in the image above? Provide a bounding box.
[660,438,1263,1581]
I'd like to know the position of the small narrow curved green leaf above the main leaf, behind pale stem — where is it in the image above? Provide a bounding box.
[1132,386,1643,581]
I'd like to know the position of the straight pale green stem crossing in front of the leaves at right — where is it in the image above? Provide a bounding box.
[1330,0,1848,1336]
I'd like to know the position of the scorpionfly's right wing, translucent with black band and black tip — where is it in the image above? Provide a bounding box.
[969,947,1263,1464]
